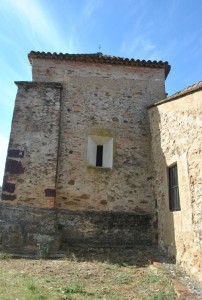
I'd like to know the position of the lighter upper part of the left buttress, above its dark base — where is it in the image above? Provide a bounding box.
[2,82,61,208]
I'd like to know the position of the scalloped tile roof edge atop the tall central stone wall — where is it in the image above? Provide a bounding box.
[28,51,170,77]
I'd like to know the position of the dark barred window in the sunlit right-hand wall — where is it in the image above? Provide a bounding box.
[168,164,180,211]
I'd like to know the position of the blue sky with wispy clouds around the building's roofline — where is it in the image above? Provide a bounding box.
[0,0,202,184]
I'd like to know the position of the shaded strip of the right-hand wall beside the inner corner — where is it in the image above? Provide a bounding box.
[149,106,178,263]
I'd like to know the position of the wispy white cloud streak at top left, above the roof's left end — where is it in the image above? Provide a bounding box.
[4,0,74,52]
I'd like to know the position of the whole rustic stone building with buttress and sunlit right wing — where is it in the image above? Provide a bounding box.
[0,52,202,282]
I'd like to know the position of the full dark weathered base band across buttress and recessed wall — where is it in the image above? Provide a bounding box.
[0,204,152,253]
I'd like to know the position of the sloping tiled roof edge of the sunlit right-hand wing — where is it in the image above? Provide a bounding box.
[148,81,202,108]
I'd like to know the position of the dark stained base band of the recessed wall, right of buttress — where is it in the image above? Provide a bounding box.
[57,209,152,249]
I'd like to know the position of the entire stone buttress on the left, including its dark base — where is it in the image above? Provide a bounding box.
[0,82,62,253]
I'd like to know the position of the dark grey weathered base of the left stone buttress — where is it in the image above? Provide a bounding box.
[0,201,61,254]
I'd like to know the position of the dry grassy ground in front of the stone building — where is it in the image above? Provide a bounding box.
[0,249,177,300]
